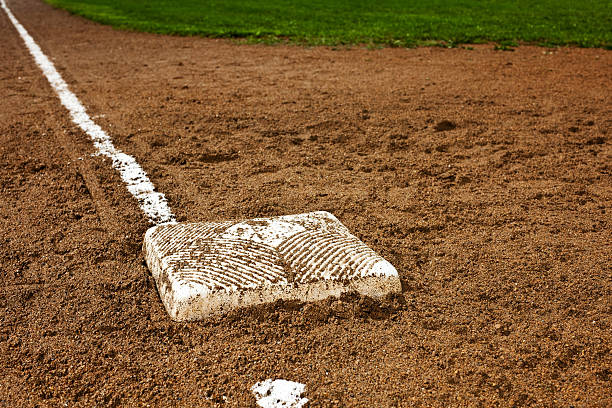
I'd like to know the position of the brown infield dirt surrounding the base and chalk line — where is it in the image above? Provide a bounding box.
[0,0,612,407]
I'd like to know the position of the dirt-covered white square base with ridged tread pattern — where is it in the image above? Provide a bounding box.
[144,211,401,320]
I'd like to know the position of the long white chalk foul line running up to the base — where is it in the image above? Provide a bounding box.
[0,0,176,224]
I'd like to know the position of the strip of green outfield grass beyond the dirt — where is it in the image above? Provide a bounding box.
[46,0,612,49]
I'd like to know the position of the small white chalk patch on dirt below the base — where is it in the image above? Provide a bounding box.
[251,379,308,408]
